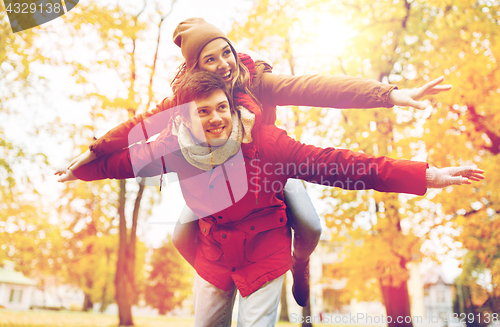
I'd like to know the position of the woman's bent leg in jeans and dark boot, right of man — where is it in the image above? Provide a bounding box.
[283,179,321,306]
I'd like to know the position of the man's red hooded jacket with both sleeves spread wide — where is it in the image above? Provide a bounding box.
[74,124,427,296]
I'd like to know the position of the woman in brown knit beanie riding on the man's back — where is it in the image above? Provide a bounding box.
[62,18,450,306]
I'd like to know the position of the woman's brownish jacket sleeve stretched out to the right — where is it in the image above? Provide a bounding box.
[259,74,396,109]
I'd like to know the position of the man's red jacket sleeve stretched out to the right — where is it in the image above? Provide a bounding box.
[273,127,428,195]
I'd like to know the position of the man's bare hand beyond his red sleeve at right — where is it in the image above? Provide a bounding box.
[425,166,484,188]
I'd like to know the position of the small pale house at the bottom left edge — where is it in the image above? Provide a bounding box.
[0,261,36,310]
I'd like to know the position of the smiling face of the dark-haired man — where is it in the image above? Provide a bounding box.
[186,90,233,146]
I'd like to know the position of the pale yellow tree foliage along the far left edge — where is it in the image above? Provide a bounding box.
[0,3,67,298]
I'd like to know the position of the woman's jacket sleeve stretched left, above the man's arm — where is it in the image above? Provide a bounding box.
[89,97,175,157]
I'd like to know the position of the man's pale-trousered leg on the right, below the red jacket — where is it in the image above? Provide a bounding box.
[238,275,285,327]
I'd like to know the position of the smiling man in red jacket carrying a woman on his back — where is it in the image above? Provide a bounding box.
[56,71,483,327]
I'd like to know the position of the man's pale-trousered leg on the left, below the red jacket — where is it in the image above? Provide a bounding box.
[193,274,237,327]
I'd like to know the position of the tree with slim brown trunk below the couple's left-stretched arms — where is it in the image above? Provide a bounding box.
[36,1,179,326]
